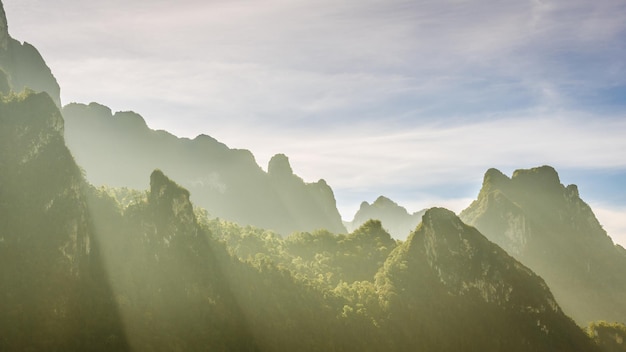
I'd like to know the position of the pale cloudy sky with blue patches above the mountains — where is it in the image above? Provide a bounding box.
[3,0,626,245]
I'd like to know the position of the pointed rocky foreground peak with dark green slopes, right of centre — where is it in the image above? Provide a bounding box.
[377,208,595,351]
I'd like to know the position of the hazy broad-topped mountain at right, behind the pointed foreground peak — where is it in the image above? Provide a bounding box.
[460,166,626,325]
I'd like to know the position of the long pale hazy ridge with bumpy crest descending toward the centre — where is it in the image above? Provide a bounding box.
[63,103,346,235]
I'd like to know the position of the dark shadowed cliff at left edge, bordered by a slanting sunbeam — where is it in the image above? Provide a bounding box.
[0,93,127,351]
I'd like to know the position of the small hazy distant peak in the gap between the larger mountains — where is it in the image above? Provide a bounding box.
[344,196,426,239]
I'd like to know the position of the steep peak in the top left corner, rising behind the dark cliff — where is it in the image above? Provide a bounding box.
[0,2,61,107]
